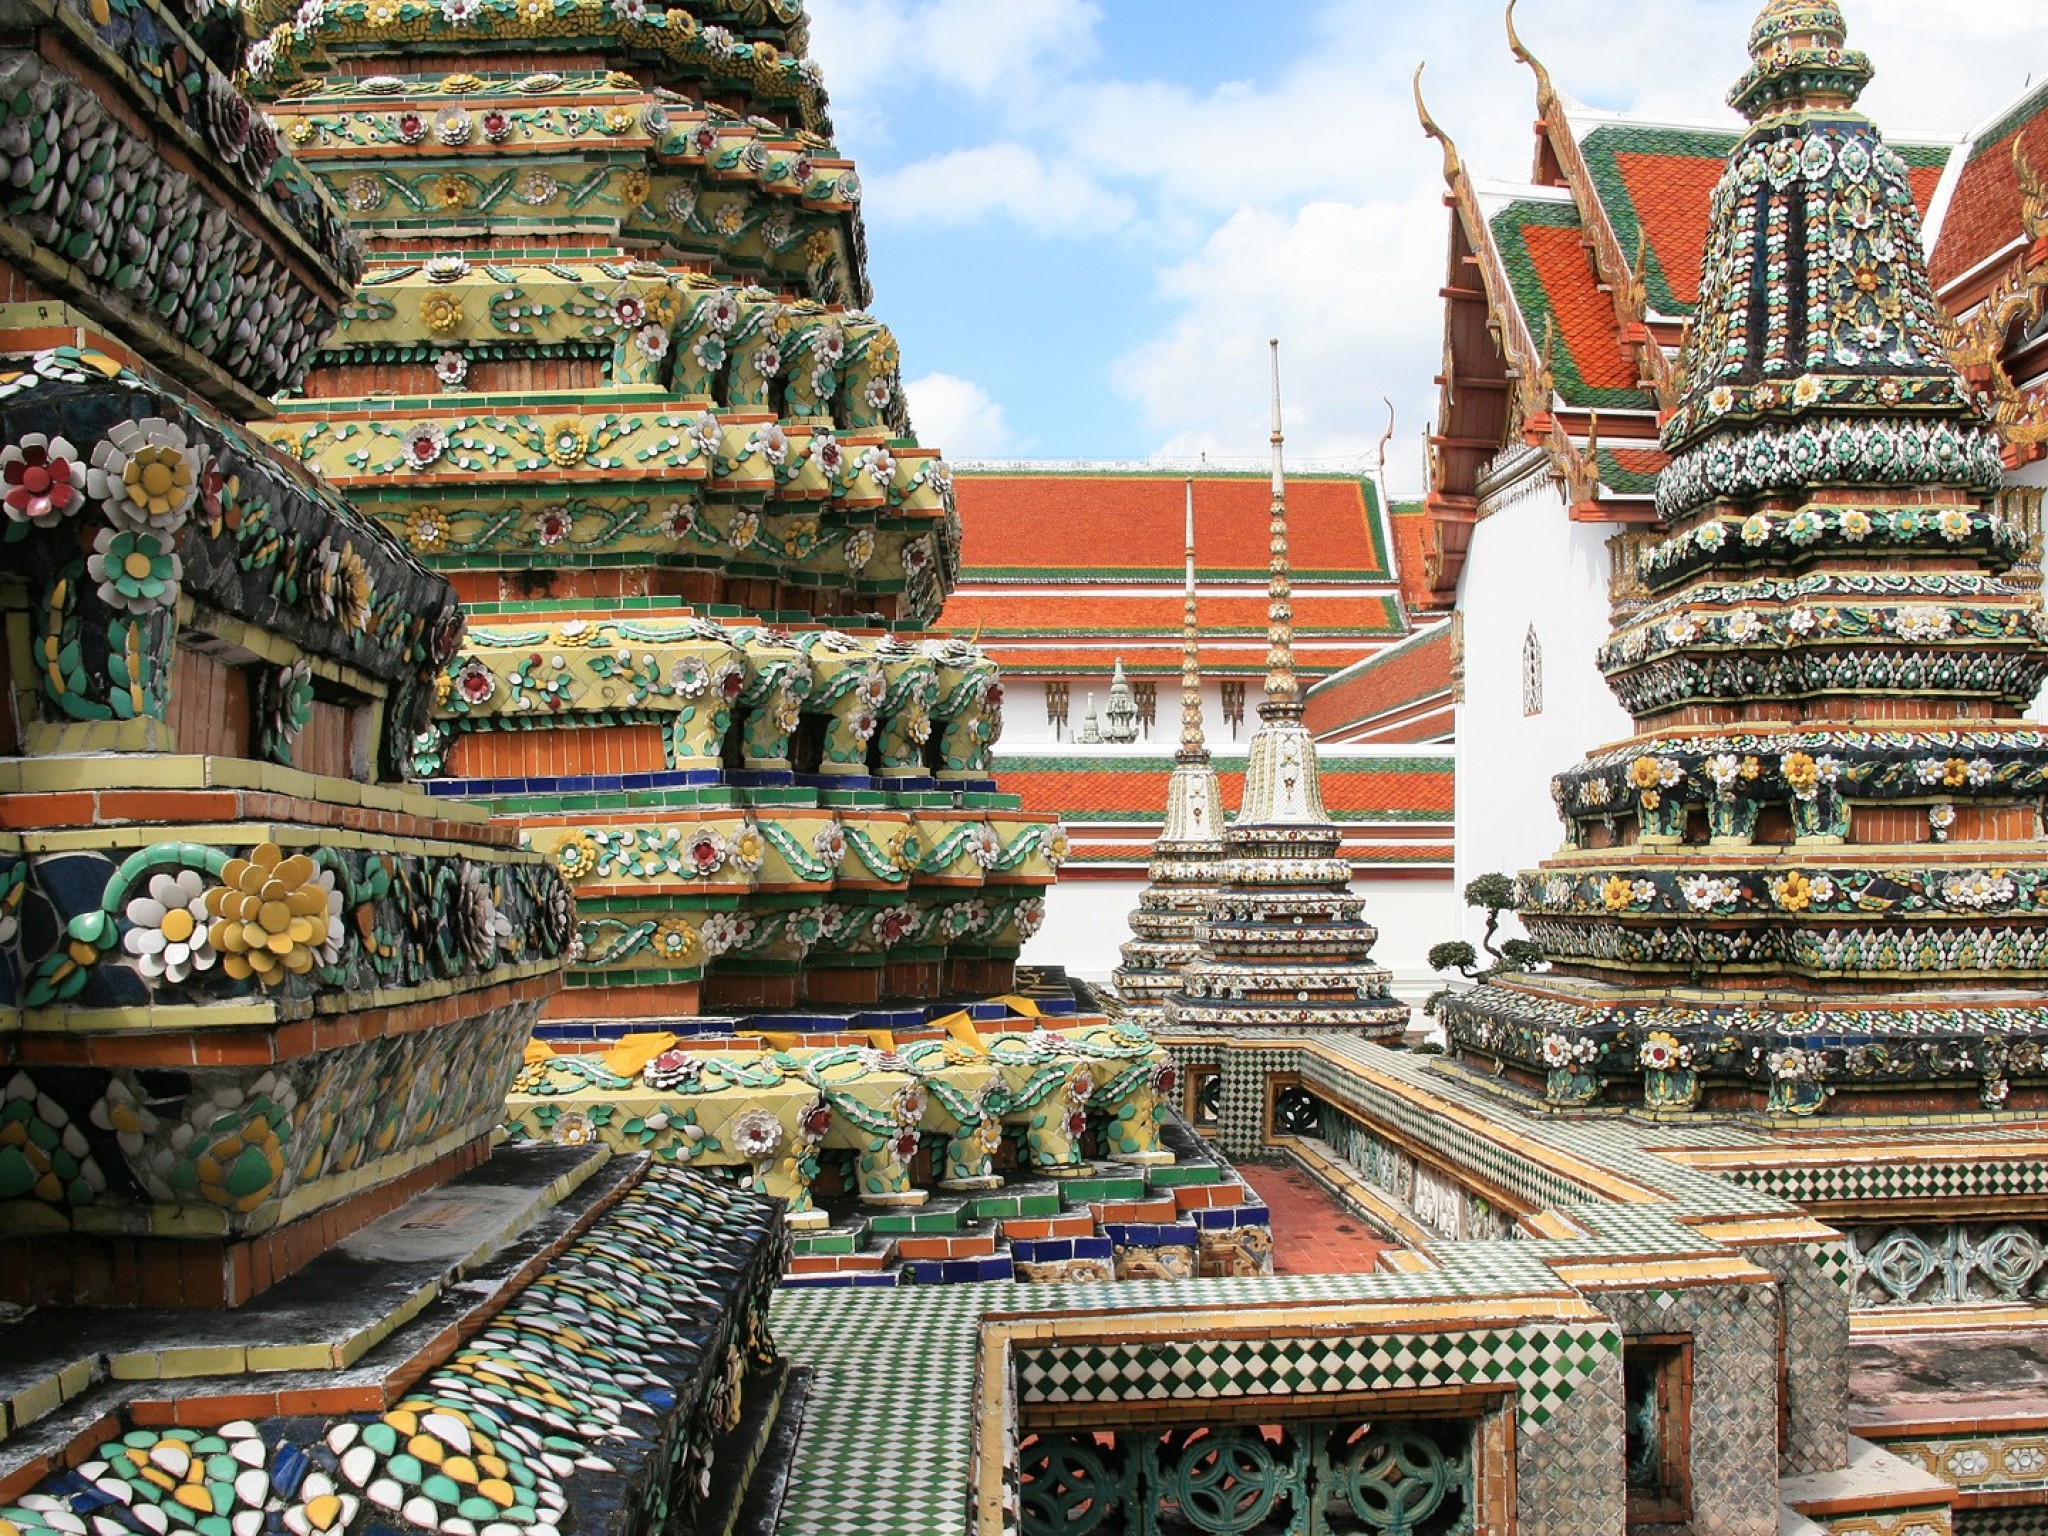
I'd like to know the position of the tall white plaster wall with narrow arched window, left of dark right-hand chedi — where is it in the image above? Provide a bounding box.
[1444,451,1630,942]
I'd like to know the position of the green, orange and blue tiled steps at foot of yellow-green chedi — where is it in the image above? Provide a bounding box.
[782,1133,1272,1288]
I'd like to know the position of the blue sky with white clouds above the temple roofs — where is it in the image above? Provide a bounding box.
[811,0,2048,487]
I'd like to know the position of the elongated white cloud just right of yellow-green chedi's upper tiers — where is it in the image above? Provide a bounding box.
[866,143,1135,236]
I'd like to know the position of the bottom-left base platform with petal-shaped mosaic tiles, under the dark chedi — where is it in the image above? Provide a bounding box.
[0,1149,784,1536]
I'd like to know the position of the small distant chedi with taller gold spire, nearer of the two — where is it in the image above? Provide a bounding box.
[1163,342,1409,1038]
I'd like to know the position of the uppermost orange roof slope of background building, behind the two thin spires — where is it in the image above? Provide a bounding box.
[954,467,1393,582]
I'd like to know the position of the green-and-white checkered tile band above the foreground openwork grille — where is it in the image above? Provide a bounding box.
[1018,1325,1622,1423]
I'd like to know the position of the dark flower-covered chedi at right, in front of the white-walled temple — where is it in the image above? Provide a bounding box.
[1446,0,2048,1114]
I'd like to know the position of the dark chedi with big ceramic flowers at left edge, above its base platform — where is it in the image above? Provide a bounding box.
[0,0,571,1302]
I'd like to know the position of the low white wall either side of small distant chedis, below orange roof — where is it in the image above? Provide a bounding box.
[1024,879,1458,1001]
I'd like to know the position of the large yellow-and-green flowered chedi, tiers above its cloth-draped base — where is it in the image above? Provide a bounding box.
[248,0,1065,1036]
